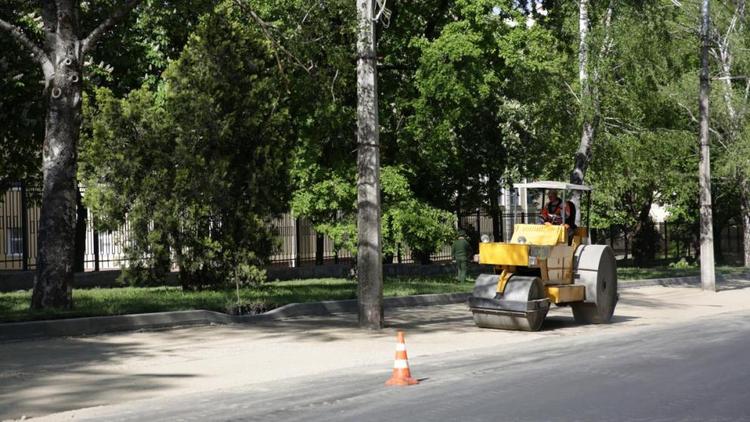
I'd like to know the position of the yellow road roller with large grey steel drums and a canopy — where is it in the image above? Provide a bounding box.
[469,181,618,331]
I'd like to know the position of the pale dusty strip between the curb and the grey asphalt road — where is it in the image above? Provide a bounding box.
[0,281,750,419]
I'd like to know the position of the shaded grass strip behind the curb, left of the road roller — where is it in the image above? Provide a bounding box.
[0,277,473,322]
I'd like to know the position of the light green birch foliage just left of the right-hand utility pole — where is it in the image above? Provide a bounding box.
[588,2,698,265]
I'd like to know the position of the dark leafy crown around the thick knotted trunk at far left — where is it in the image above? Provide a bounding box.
[0,0,215,186]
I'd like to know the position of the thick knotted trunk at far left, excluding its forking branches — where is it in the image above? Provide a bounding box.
[31,32,82,309]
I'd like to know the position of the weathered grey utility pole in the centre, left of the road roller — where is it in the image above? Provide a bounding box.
[356,0,383,330]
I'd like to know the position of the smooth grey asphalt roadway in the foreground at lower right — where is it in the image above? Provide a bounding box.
[51,311,750,422]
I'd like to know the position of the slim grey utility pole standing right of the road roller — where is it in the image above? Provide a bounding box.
[698,0,716,292]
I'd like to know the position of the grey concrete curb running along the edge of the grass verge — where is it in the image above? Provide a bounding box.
[0,273,750,342]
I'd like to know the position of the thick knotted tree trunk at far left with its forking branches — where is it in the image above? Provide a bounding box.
[0,0,140,309]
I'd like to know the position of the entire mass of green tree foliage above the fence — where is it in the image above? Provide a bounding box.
[7,0,750,284]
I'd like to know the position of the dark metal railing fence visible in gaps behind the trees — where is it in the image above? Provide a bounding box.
[0,184,743,271]
